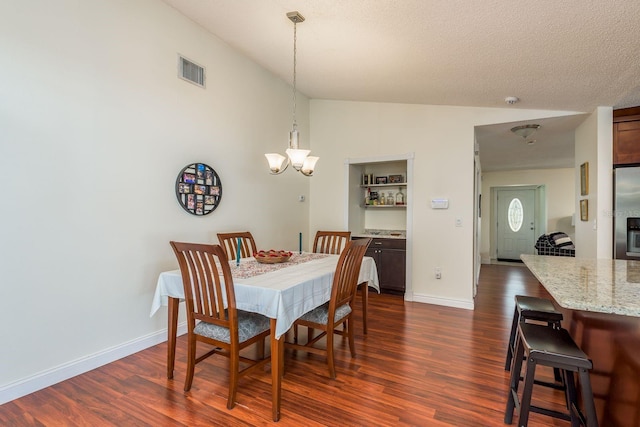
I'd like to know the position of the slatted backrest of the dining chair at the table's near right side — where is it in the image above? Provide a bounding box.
[329,238,371,312]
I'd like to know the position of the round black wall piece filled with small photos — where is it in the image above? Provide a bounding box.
[176,163,222,216]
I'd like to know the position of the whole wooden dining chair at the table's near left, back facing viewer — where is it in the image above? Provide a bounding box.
[170,242,270,409]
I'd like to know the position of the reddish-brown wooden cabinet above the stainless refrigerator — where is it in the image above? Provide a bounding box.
[613,107,640,165]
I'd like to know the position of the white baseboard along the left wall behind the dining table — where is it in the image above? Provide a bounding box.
[0,322,187,405]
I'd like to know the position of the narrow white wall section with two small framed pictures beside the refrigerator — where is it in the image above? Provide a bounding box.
[575,107,613,259]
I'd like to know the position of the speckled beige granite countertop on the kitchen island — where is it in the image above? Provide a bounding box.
[520,255,640,317]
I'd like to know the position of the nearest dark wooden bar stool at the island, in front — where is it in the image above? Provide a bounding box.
[504,323,598,427]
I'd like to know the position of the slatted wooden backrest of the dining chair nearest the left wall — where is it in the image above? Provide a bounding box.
[170,242,237,330]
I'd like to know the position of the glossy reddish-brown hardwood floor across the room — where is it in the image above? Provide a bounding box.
[0,265,569,427]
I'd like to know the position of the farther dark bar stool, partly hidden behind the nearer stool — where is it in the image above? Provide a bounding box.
[504,295,562,372]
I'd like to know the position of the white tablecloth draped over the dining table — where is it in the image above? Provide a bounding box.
[150,255,380,338]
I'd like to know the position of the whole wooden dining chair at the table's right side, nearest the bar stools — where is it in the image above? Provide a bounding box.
[285,238,371,378]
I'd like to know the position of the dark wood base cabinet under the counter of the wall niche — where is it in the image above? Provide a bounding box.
[354,237,407,295]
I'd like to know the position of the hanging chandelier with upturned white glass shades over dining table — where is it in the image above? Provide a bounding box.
[265,11,319,176]
